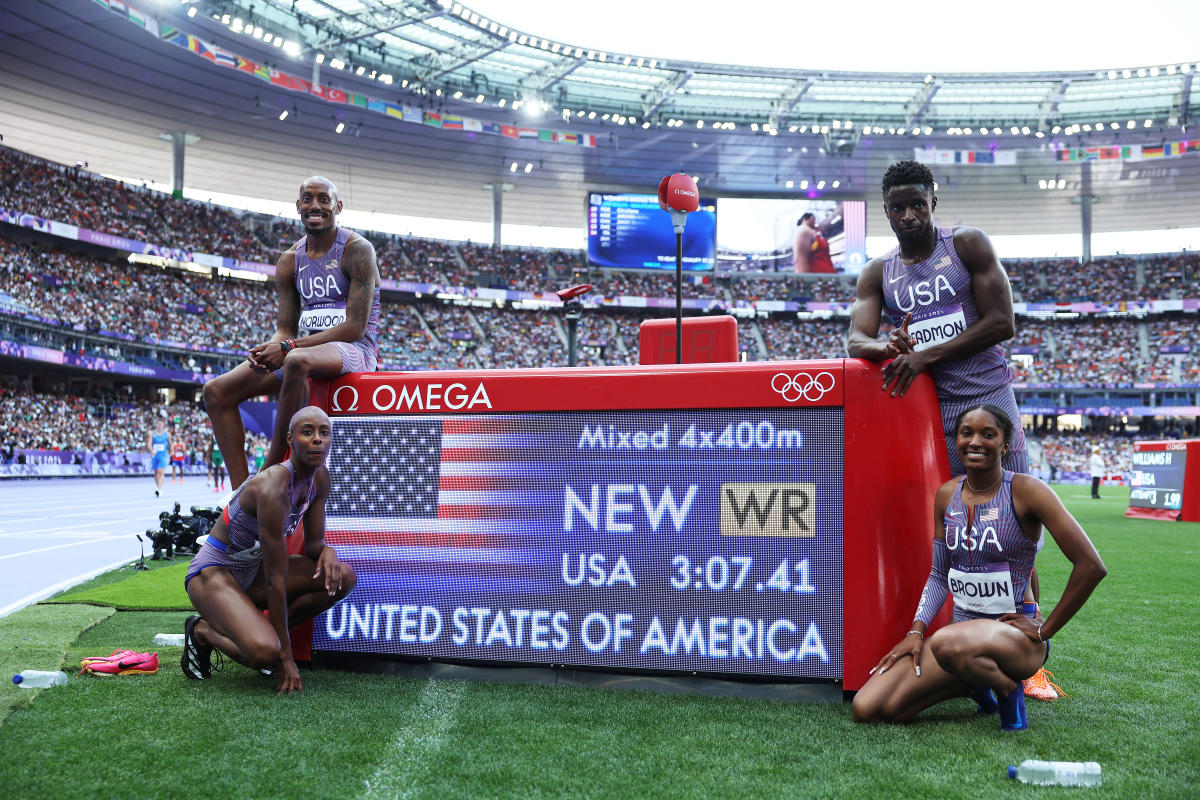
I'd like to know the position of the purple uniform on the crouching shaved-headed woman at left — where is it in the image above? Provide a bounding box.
[184,461,317,590]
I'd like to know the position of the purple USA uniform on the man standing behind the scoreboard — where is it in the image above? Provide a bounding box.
[883,228,1030,475]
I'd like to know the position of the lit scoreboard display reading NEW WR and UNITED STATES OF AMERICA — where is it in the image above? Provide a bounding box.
[313,407,844,680]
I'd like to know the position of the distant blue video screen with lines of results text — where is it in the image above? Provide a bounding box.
[588,192,716,271]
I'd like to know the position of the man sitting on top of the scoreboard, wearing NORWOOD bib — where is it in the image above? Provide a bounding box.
[204,176,379,487]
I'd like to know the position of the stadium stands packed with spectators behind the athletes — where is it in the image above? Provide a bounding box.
[0,148,1200,476]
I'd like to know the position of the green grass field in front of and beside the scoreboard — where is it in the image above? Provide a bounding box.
[0,487,1200,800]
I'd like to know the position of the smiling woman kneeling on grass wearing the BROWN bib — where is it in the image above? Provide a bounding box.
[852,403,1106,730]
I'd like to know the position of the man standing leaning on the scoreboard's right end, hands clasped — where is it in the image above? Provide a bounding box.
[846,161,1030,475]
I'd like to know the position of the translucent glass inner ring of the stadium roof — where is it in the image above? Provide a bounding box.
[211,0,1198,139]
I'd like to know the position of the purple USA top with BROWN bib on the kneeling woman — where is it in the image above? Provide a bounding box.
[914,469,1043,625]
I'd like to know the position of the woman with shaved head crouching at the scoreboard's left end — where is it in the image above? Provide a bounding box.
[180,405,355,693]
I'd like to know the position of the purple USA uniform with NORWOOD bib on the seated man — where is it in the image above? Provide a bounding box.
[275,228,379,380]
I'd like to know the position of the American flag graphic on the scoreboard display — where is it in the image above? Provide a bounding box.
[325,415,556,590]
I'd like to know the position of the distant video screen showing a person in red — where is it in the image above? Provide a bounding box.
[716,197,866,275]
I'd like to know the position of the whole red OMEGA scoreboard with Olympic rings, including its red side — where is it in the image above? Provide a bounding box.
[313,360,946,688]
